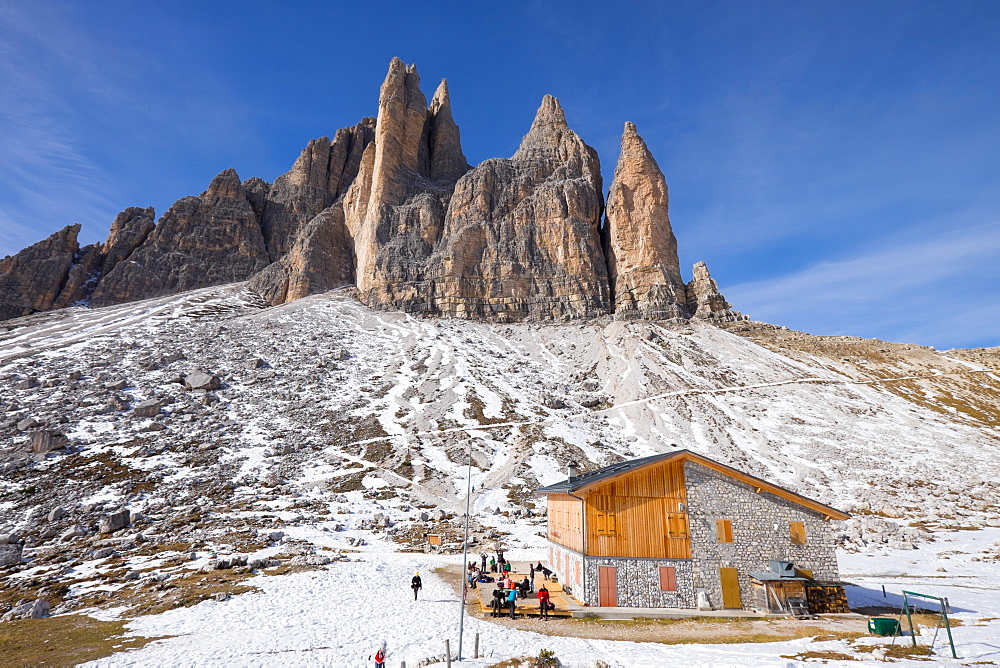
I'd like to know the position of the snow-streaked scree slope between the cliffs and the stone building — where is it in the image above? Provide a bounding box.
[0,285,1000,541]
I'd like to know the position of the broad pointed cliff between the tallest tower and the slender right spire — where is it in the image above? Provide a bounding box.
[430,96,610,321]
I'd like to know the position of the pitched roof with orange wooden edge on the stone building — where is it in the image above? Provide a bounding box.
[535,450,850,520]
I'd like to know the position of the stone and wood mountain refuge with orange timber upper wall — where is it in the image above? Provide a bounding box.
[537,450,849,614]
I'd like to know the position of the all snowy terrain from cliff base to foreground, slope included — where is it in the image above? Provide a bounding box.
[0,285,1000,668]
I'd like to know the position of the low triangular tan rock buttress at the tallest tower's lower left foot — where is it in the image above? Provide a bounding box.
[247,202,354,305]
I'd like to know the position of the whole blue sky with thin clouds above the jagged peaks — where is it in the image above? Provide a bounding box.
[0,0,1000,348]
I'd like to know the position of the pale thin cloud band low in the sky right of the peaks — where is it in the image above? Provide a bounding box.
[724,221,1000,348]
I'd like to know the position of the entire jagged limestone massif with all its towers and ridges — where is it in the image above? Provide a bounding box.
[0,58,743,322]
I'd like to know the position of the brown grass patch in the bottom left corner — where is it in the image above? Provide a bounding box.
[0,615,168,667]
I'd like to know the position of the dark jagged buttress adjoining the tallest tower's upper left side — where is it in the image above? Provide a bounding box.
[260,118,375,260]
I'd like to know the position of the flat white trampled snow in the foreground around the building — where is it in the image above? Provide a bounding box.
[88,529,1000,668]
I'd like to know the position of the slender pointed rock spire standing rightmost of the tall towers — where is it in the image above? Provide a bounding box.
[605,123,688,320]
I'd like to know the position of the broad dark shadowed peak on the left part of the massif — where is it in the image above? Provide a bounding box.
[91,169,268,306]
